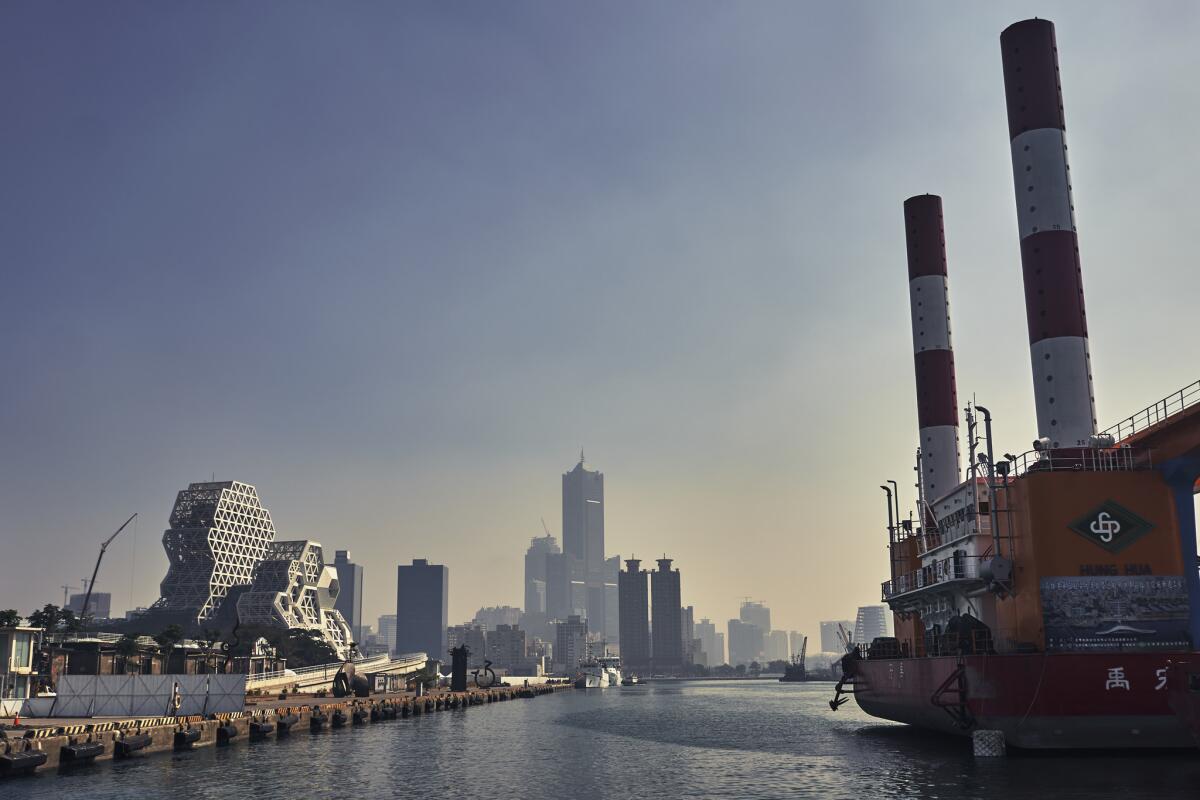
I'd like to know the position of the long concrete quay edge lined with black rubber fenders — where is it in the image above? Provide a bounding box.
[0,684,571,780]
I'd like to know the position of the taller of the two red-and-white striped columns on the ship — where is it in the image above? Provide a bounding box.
[1000,19,1096,447]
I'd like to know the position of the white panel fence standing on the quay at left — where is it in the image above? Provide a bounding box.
[49,675,246,717]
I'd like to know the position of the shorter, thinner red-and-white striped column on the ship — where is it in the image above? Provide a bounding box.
[904,194,959,503]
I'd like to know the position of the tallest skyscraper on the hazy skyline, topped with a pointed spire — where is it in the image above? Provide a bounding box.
[563,452,608,633]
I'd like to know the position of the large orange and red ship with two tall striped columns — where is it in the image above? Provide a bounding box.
[830,19,1200,750]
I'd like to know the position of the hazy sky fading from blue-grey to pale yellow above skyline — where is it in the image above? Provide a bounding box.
[0,0,1200,636]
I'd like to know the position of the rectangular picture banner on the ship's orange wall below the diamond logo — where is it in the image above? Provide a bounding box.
[1040,576,1190,652]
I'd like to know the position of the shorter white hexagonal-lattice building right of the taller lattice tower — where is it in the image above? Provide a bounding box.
[238,541,353,657]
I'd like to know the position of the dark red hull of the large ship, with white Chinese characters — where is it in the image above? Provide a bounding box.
[853,652,1195,750]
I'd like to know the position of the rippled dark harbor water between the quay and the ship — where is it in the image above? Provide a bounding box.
[9,681,1200,800]
